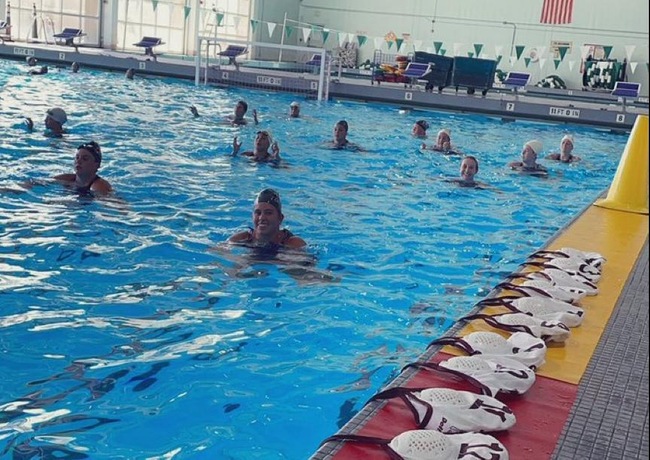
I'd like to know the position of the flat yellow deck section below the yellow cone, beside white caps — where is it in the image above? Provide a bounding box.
[444,206,648,384]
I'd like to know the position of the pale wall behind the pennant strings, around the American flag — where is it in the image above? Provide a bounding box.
[296,0,648,95]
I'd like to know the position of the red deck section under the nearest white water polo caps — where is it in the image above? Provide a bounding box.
[326,353,578,460]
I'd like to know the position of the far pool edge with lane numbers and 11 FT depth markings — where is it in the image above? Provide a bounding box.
[0,42,648,132]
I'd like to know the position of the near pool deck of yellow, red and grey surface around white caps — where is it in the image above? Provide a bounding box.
[311,201,650,460]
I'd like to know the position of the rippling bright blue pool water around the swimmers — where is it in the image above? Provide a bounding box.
[0,61,627,459]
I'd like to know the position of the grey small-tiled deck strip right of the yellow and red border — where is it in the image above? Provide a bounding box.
[552,241,650,460]
